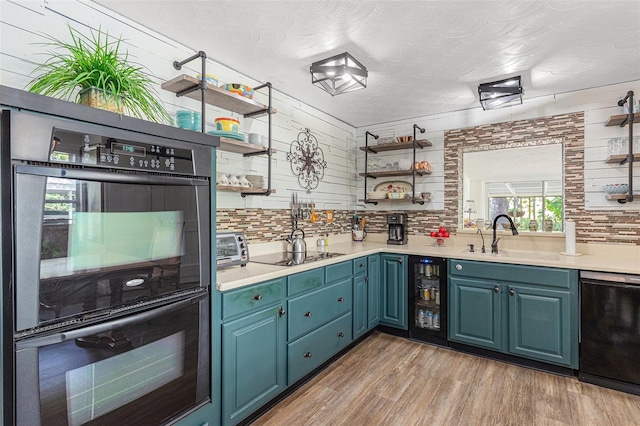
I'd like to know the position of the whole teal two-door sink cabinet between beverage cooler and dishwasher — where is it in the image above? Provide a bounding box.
[449,260,579,369]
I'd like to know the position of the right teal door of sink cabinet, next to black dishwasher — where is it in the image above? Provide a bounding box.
[509,285,571,364]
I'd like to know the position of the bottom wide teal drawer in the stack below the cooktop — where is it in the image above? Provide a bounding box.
[287,313,351,385]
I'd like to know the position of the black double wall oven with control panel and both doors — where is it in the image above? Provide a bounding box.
[2,110,211,426]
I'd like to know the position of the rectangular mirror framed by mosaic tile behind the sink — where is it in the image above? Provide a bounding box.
[462,143,564,232]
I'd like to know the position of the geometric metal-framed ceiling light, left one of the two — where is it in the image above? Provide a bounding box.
[310,52,368,96]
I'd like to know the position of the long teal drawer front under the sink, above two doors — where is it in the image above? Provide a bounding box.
[449,259,577,288]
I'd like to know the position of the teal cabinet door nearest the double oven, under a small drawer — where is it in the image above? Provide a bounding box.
[222,306,287,425]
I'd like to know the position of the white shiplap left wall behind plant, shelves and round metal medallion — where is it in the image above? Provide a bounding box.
[0,0,356,209]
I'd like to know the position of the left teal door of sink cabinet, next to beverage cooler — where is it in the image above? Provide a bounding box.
[449,277,502,350]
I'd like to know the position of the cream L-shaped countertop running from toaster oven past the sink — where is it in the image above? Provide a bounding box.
[216,237,640,291]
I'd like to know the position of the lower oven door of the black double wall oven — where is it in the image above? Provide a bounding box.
[15,296,211,426]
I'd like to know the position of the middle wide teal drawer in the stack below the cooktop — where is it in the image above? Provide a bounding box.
[287,278,352,341]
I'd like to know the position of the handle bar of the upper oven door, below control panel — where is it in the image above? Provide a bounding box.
[16,165,209,186]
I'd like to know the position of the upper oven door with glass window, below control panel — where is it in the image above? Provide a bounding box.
[15,166,210,330]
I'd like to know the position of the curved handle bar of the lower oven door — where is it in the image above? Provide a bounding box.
[16,292,208,350]
